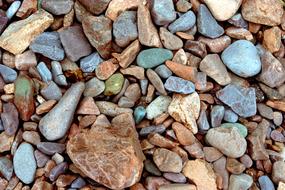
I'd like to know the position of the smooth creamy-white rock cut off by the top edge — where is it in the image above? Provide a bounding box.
[205,0,242,21]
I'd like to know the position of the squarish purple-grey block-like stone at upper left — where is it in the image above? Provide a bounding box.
[59,25,92,61]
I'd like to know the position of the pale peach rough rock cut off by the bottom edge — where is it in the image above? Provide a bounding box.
[182,159,217,190]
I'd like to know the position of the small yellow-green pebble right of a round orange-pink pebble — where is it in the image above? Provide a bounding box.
[104,73,124,96]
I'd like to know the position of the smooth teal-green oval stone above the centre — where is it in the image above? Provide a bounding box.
[137,48,173,69]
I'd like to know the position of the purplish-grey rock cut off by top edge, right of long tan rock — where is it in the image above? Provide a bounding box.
[41,0,74,15]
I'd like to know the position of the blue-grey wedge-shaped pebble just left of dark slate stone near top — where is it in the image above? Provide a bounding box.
[168,10,196,33]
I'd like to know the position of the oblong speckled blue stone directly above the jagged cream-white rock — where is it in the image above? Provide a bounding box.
[164,76,195,94]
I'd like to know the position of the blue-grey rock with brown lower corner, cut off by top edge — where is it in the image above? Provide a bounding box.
[151,0,176,26]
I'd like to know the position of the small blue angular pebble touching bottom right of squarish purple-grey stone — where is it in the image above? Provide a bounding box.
[80,52,103,73]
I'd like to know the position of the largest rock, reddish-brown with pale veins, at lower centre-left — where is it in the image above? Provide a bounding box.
[67,113,145,189]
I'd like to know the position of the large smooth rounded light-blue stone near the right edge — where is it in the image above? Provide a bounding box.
[221,40,261,78]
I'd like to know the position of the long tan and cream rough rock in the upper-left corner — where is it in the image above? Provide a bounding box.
[0,10,53,54]
